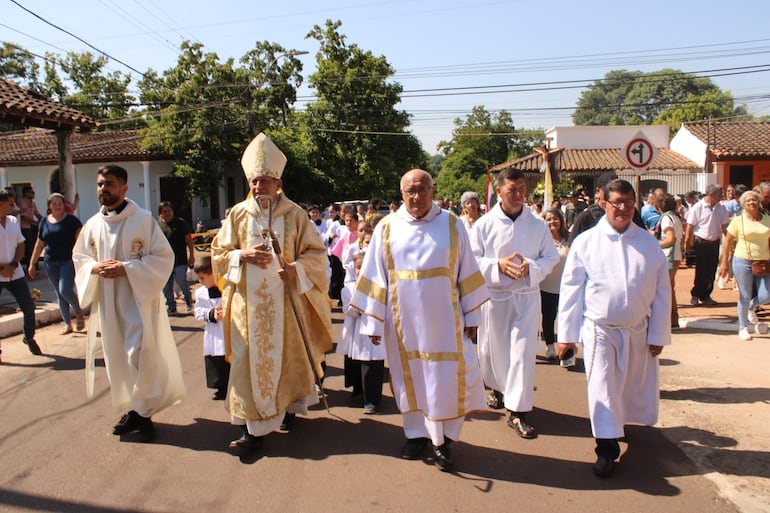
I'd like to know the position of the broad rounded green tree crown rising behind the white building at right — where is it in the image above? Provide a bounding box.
[572,69,734,125]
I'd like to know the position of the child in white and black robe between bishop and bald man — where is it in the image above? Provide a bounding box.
[337,249,385,415]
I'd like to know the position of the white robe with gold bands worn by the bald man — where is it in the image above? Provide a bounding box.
[350,205,488,446]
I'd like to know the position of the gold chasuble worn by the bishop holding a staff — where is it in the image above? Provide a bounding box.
[211,195,332,421]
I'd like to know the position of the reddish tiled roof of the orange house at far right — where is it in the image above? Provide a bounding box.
[682,121,770,158]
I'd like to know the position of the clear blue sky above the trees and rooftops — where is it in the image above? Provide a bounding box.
[0,0,770,153]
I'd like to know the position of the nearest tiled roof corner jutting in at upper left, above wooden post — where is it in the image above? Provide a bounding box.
[0,78,97,129]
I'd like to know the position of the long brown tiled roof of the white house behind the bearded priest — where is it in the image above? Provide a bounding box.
[0,130,171,166]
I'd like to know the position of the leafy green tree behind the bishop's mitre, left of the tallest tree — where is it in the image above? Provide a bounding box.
[139,41,302,201]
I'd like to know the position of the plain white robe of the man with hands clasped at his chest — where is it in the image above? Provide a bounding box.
[470,203,559,412]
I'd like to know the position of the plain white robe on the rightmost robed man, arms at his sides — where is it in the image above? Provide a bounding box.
[559,217,671,438]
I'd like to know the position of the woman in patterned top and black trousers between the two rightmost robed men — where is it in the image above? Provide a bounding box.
[540,208,569,360]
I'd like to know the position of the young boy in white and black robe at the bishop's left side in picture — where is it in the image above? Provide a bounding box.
[193,256,230,401]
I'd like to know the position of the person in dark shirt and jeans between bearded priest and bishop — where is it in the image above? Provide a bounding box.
[158,201,195,314]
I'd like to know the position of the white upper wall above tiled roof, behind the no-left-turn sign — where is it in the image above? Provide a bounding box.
[545,125,669,150]
